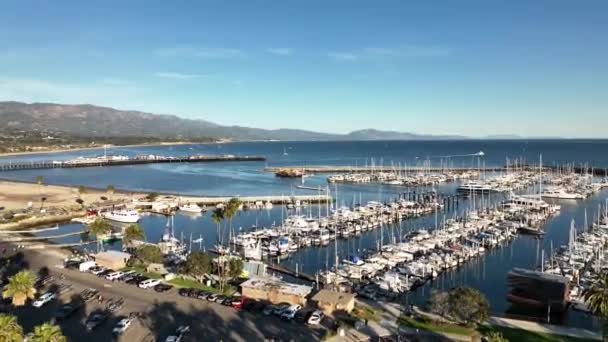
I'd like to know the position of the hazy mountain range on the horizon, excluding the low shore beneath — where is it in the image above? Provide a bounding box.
[0,101,498,140]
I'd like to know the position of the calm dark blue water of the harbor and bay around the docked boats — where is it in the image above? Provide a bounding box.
[0,140,608,327]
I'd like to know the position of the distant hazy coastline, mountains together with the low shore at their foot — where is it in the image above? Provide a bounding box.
[0,101,560,153]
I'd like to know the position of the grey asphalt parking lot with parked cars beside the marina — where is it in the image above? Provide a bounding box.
[1,246,325,342]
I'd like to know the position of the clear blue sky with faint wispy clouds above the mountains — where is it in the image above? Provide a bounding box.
[0,0,608,137]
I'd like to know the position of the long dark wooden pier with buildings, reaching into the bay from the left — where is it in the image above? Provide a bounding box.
[0,155,266,172]
